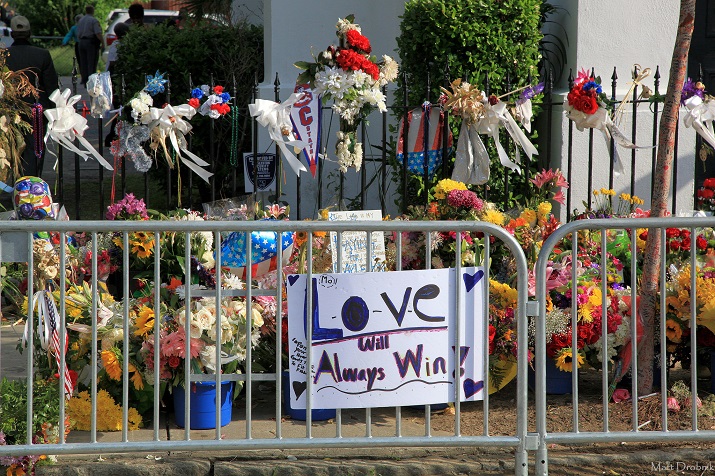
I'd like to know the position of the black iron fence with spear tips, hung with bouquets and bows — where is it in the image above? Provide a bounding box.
[32,63,702,219]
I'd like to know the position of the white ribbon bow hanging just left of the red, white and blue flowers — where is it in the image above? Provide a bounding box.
[142,104,213,183]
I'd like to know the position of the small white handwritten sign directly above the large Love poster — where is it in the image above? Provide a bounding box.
[328,210,385,273]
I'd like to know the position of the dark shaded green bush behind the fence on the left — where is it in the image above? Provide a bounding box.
[113,24,263,201]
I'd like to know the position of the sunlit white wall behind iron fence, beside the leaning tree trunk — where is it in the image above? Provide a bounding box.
[551,0,695,215]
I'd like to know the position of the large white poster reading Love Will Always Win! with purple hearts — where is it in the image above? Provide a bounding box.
[287,267,486,408]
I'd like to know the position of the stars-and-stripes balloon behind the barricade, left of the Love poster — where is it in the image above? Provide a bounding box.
[221,231,293,279]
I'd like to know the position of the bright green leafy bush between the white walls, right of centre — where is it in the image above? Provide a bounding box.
[396,0,543,208]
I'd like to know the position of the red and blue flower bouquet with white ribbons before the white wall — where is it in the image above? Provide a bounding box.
[564,69,652,175]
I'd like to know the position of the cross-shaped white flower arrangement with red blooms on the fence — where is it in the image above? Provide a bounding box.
[295,15,398,172]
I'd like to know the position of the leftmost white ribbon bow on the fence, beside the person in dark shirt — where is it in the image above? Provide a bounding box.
[45,89,114,170]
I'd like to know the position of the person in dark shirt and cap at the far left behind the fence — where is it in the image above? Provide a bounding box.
[6,16,59,176]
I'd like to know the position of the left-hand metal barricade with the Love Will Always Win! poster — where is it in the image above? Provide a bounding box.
[0,220,534,474]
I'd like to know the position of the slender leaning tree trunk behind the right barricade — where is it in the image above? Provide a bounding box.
[638,0,695,395]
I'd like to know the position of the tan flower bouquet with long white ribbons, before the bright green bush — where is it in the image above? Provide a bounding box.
[440,79,543,185]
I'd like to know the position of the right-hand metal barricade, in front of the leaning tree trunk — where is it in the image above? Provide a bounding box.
[530,217,715,475]
